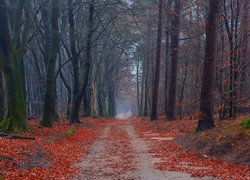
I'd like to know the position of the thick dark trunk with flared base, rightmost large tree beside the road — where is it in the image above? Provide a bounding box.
[197,0,220,131]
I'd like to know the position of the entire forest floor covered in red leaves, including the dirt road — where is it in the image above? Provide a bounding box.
[0,118,250,180]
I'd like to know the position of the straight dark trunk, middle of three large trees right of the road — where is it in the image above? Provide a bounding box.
[167,0,181,120]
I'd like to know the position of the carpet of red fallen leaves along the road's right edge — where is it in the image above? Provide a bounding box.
[133,119,250,180]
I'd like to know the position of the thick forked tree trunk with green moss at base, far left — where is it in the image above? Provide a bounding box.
[0,0,30,132]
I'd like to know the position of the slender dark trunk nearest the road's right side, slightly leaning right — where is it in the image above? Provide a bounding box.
[150,0,163,121]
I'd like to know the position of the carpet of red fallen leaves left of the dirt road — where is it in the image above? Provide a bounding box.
[0,118,103,179]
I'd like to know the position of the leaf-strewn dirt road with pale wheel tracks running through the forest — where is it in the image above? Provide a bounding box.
[74,120,212,180]
